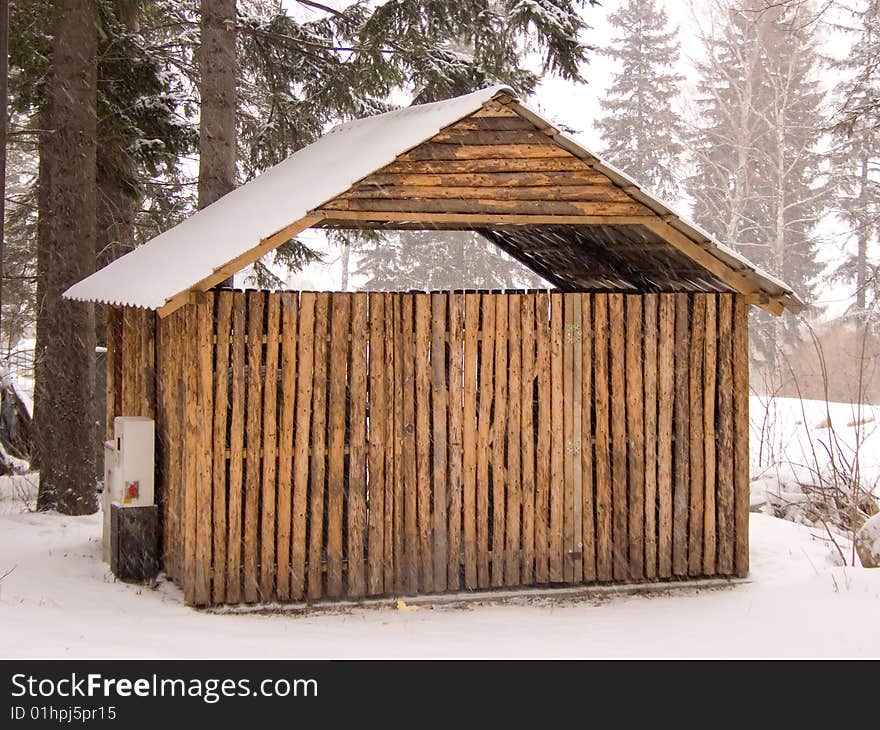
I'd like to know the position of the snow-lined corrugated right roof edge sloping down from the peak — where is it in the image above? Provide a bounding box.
[511,97,807,314]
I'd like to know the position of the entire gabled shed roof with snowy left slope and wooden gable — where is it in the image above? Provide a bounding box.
[65,87,803,314]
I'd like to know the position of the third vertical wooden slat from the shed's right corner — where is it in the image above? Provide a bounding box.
[703,294,718,575]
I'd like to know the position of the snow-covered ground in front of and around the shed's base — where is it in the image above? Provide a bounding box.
[0,466,880,658]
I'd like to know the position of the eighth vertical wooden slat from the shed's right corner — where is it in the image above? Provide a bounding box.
[626,294,645,580]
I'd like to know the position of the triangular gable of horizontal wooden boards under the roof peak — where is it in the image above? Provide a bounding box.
[321,102,654,220]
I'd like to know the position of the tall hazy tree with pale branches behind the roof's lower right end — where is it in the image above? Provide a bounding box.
[688,2,827,370]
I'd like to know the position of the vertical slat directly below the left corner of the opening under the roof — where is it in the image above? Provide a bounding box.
[225,292,247,603]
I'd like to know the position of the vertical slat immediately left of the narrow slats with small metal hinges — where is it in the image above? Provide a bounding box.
[550,293,566,582]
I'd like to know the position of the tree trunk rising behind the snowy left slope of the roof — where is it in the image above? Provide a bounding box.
[199,0,236,286]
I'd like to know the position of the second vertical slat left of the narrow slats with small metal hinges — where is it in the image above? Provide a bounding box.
[535,294,551,583]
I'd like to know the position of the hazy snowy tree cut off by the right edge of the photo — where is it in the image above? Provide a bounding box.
[831,0,880,317]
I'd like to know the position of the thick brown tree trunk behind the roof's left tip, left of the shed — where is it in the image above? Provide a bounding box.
[34,0,97,514]
